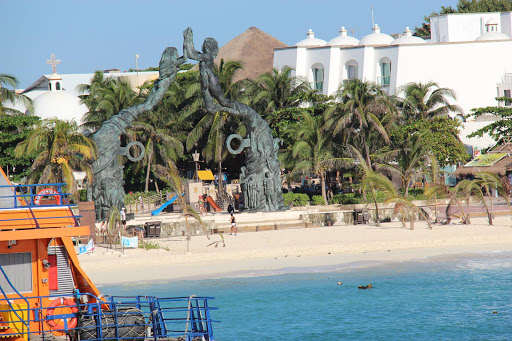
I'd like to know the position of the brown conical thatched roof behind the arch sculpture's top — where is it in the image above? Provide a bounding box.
[215,26,287,82]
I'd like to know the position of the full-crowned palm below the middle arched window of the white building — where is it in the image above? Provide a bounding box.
[325,79,394,167]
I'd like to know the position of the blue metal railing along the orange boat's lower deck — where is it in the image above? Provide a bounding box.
[0,293,218,341]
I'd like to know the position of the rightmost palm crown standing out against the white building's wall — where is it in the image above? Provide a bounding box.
[397,82,462,119]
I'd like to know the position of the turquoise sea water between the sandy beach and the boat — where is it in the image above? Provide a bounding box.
[102,253,512,341]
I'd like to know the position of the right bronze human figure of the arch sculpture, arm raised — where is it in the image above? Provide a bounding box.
[183,28,287,211]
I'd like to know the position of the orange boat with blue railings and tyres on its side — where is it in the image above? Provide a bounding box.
[0,169,215,341]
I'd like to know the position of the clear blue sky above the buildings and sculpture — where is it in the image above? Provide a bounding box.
[0,0,458,88]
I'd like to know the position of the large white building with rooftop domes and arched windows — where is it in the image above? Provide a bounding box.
[274,12,512,148]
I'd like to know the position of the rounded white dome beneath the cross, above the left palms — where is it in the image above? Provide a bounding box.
[28,91,89,124]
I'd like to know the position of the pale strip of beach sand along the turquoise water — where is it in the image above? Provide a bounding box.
[79,216,512,285]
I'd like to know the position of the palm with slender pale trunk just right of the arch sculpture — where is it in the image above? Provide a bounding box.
[281,112,351,203]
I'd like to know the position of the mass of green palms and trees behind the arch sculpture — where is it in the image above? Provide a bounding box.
[5,60,472,222]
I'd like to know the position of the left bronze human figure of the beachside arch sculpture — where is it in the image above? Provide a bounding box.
[92,47,186,220]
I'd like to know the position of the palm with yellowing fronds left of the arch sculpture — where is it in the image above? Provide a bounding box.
[14,119,96,195]
